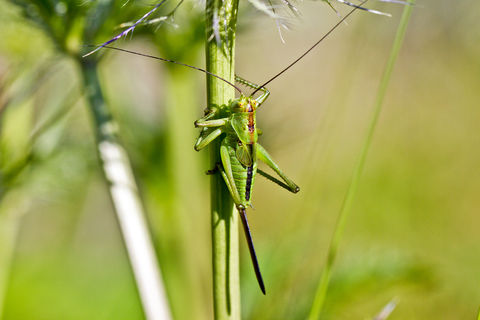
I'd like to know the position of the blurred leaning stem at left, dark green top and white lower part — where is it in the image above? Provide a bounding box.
[81,59,171,320]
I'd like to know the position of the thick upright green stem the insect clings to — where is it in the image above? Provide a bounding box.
[206,0,240,320]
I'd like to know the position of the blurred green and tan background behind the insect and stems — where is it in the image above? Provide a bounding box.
[0,0,480,320]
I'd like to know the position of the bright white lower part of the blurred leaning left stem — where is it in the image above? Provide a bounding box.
[99,141,172,320]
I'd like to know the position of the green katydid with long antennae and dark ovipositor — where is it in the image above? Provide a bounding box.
[86,0,368,294]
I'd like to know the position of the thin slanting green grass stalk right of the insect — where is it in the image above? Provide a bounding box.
[308,0,415,320]
